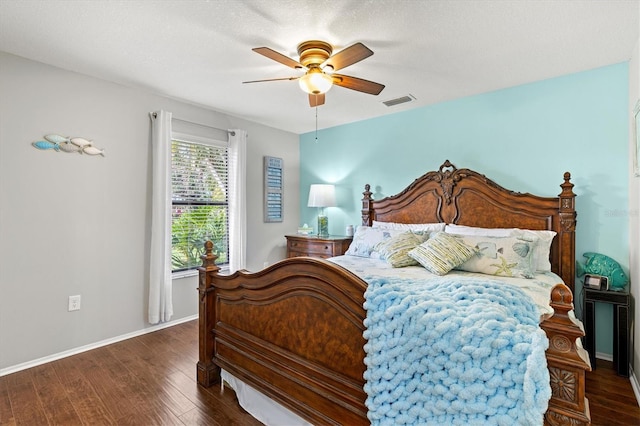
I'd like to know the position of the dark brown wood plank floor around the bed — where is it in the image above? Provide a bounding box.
[0,321,640,426]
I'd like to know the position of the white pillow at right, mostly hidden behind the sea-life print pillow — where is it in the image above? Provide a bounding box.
[444,224,556,272]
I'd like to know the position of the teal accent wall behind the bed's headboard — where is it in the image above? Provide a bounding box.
[300,63,629,354]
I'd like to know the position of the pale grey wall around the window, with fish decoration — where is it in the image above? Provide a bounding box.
[0,52,299,374]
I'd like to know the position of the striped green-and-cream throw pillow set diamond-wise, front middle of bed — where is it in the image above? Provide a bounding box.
[408,232,475,275]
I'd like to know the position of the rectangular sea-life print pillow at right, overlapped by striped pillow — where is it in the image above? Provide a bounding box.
[447,234,537,278]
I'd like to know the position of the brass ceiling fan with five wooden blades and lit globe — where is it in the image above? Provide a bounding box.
[243,40,384,107]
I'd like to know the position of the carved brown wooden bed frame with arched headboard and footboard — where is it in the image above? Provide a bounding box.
[197,160,591,425]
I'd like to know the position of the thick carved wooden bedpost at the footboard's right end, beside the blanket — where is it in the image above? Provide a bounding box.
[540,284,591,426]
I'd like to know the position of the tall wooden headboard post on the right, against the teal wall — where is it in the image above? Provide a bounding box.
[558,172,577,292]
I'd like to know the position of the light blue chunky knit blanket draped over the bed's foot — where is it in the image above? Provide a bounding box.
[364,276,551,426]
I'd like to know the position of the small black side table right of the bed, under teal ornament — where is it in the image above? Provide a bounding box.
[583,288,630,377]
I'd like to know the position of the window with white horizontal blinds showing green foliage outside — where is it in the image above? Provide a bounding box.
[171,134,229,272]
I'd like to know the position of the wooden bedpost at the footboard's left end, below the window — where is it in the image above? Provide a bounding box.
[197,241,220,387]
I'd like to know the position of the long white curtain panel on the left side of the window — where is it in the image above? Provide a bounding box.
[149,111,173,324]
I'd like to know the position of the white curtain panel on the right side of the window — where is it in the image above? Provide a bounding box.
[229,129,247,273]
